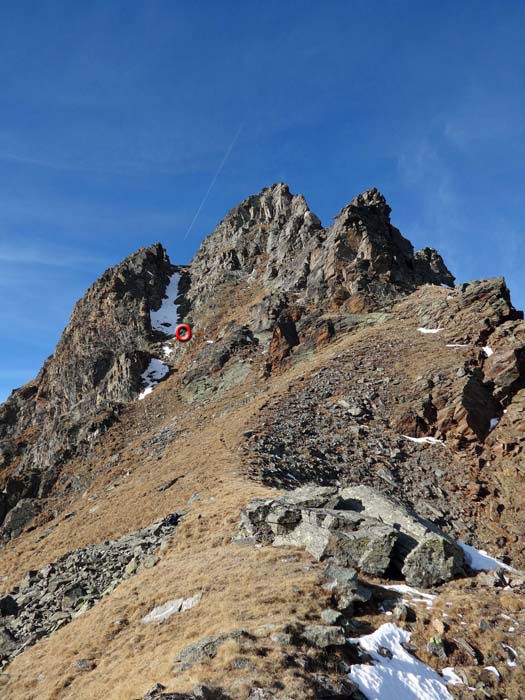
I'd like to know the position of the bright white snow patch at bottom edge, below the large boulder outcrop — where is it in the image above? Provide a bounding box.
[349,622,452,700]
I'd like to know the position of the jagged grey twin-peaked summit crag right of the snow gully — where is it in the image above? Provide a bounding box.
[190,183,454,309]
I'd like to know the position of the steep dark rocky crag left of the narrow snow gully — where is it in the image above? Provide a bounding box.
[0,244,180,532]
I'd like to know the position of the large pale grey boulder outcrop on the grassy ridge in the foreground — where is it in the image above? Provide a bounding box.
[237,486,464,587]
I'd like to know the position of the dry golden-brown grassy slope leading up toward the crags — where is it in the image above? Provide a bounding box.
[0,288,520,700]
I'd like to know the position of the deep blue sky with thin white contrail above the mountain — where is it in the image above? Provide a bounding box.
[0,0,525,400]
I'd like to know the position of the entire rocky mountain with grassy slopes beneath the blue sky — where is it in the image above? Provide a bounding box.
[0,184,525,700]
